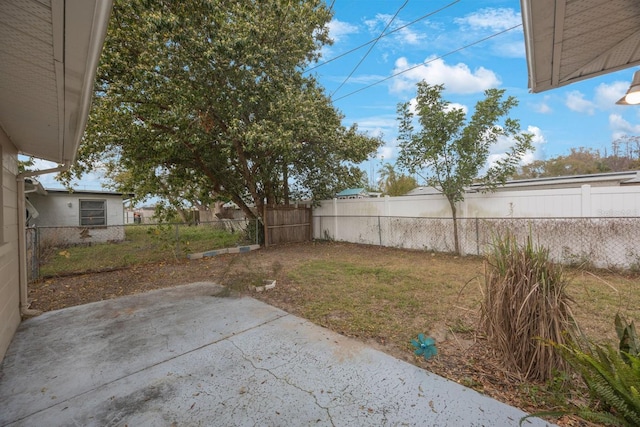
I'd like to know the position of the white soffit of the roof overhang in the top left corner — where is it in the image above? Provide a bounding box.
[0,0,112,164]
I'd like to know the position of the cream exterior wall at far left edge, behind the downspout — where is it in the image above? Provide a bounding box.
[0,128,20,360]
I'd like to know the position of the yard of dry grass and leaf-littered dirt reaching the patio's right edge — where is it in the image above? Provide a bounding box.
[221,243,640,425]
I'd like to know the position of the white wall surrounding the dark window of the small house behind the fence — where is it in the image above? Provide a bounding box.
[28,192,125,244]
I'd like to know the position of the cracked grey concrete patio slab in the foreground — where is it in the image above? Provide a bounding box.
[0,283,549,426]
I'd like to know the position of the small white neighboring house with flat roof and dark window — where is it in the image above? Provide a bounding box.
[27,189,131,244]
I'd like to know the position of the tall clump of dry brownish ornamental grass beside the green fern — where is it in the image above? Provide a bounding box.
[481,234,575,381]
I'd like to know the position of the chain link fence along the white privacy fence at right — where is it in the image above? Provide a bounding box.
[313,216,640,270]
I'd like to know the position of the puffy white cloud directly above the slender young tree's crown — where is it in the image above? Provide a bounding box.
[391,57,501,94]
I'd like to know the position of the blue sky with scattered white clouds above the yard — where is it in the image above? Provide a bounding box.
[31,0,640,190]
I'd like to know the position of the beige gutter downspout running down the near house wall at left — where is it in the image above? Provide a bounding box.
[16,164,71,316]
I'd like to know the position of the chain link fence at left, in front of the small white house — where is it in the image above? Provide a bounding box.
[30,219,264,281]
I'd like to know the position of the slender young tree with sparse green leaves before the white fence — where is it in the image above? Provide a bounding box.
[397,81,533,253]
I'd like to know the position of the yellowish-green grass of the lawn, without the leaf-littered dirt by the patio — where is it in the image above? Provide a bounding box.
[236,243,640,343]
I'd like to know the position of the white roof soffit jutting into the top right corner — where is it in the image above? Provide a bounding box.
[520,0,640,92]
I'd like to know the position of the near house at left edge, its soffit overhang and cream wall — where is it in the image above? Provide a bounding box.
[0,0,112,360]
